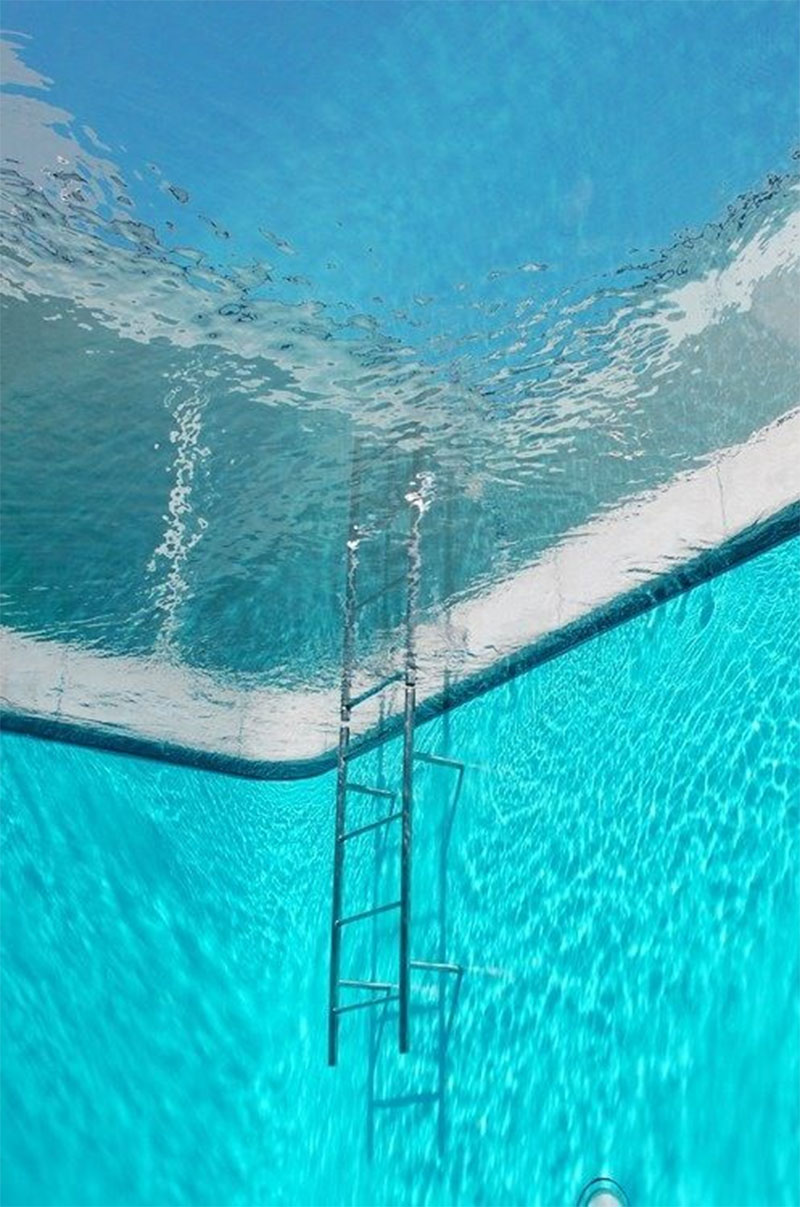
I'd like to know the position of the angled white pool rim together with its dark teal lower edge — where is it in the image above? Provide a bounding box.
[0,424,800,780]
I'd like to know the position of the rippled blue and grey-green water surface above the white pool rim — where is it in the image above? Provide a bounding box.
[2,2,800,700]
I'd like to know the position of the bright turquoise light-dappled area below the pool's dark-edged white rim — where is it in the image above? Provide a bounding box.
[1,541,800,1207]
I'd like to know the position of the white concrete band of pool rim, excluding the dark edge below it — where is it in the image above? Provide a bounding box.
[0,409,800,763]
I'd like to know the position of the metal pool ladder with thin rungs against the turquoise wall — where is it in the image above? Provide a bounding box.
[328,457,463,1071]
